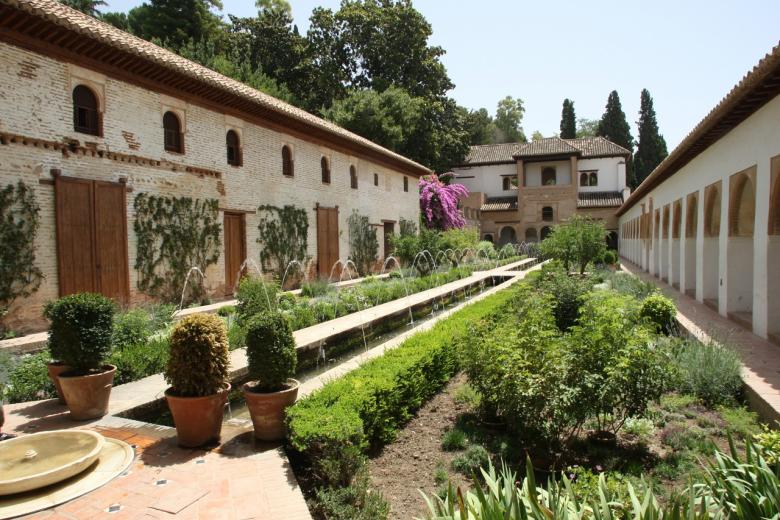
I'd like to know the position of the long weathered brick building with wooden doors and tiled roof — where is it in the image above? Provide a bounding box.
[0,0,430,328]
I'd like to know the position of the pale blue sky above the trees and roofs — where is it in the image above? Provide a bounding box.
[106,0,780,151]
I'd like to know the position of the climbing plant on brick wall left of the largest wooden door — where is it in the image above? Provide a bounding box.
[0,181,43,332]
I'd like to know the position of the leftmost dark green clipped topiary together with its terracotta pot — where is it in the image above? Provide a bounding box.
[44,293,116,421]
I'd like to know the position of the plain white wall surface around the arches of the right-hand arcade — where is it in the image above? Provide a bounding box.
[620,97,780,337]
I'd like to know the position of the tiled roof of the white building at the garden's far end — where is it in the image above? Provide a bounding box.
[464,137,630,166]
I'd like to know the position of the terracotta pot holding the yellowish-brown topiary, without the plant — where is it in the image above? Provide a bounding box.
[165,384,231,448]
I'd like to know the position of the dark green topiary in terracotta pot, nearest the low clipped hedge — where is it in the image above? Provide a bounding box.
[244,311,300,441]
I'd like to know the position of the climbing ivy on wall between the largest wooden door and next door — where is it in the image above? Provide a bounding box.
[133,193,222,303]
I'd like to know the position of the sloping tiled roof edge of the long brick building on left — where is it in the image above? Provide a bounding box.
[0,0,430,174]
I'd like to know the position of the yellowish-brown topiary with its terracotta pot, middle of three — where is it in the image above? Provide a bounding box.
[165,314,230,448]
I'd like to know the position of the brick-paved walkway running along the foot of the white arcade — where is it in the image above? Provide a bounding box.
[621,259,780,422]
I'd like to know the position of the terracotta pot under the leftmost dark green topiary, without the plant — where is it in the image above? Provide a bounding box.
[58,365,116,421]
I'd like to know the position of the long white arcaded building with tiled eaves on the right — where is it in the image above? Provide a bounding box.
[617,42,780,344]
